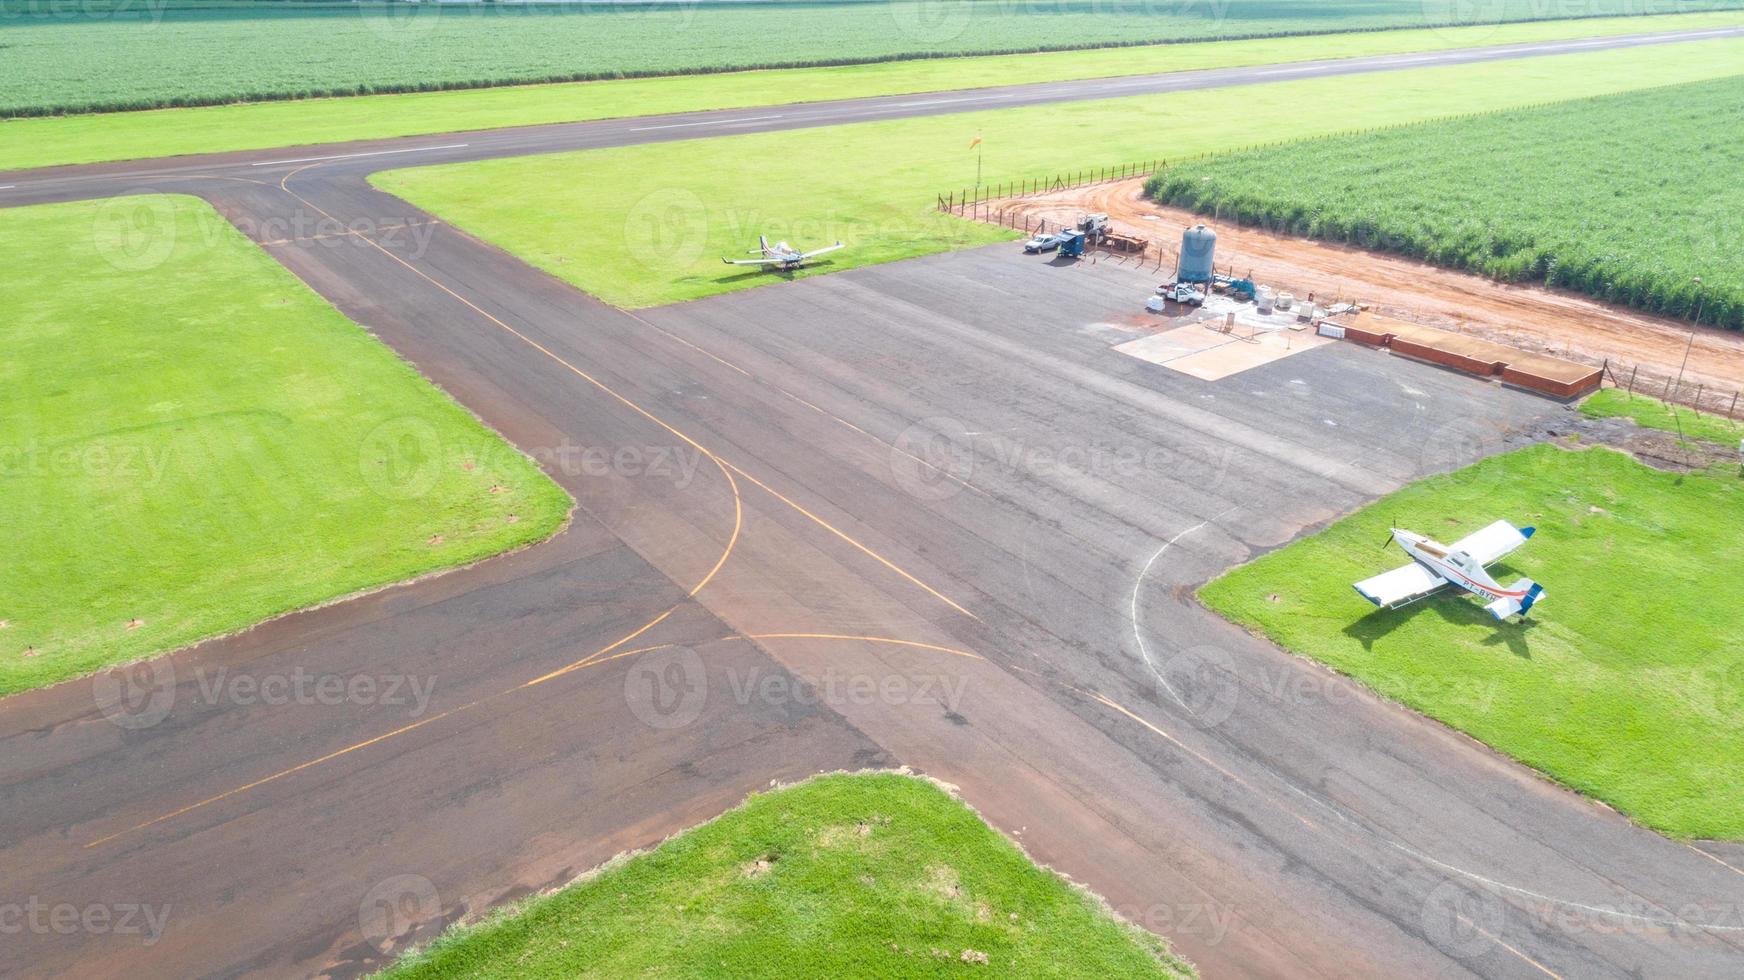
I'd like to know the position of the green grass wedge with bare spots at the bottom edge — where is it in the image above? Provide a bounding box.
[382,774,1195,980]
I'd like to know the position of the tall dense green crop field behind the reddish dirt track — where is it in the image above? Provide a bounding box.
[1149,77,1744,330]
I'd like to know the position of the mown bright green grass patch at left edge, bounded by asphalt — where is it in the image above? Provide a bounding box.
[0,195,569,696]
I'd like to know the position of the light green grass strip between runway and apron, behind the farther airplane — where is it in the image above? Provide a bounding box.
[371,40,1744,307]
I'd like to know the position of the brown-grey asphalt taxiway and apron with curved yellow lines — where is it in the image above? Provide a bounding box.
[0,22,1744,977]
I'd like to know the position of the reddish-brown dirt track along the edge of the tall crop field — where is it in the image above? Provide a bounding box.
[989,178,1744,412]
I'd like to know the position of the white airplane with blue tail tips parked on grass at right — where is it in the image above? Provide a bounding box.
[1357,521,1543,619]
